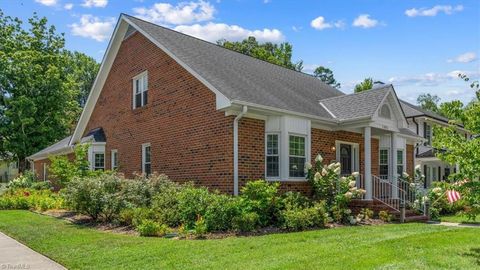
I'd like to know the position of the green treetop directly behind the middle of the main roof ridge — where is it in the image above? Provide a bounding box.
[217,37,303,71]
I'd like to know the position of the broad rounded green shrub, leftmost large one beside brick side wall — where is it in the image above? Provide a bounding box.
[63,174,125,221]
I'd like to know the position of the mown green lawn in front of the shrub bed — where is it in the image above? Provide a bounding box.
[0,211,480,269]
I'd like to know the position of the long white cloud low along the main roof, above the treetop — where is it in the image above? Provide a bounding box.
[173,22,285,42]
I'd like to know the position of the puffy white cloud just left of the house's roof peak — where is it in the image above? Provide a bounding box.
[69,14,115,41]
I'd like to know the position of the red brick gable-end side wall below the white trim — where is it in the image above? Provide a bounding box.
[85,33,237,192]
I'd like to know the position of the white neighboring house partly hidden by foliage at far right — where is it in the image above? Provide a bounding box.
[401,101,470,188]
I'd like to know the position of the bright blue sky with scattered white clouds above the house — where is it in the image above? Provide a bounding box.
[0,0,480,102]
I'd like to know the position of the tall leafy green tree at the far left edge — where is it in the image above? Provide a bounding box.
[0,10,97,170]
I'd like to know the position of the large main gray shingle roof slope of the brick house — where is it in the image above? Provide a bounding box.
[125,15,344,118]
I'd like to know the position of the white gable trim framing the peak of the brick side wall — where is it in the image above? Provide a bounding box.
[70,14,231,145]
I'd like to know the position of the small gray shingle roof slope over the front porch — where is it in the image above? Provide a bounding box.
[320,85,391,120]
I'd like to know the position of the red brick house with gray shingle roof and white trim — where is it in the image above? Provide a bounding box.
[29,15,423,213]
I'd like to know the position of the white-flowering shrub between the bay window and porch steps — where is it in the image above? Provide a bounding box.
[305,155,365,223]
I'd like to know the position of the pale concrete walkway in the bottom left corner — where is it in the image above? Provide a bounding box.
[0,232,66,270]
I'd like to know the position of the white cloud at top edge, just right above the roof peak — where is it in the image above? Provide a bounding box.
[133,0,215,25]
